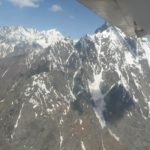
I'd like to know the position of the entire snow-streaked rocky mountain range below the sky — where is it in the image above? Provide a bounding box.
[0,26,150,150]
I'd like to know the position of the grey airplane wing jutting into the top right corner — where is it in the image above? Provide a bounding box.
[78,0,150,37]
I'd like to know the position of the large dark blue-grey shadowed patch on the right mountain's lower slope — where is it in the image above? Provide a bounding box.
[103,85,134,123]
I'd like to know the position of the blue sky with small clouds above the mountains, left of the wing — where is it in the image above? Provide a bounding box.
[0,0,104,38]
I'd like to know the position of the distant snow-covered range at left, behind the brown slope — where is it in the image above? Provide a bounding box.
[0,26,68,58]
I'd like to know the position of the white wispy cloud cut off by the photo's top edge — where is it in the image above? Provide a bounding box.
[8,0,41,8]
